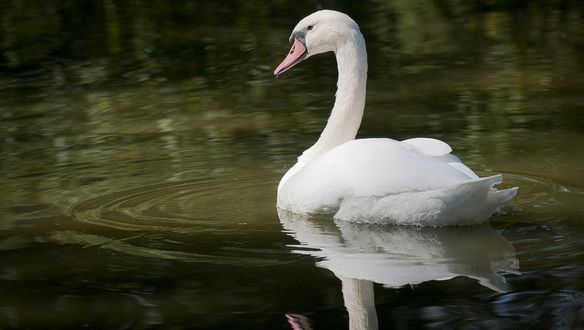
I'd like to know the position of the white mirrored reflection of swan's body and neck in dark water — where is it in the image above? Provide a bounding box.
[278,210,519,329]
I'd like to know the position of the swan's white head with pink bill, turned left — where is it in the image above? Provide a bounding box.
[274,10,359,75]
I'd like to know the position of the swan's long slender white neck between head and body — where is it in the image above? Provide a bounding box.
[298,30,367,164]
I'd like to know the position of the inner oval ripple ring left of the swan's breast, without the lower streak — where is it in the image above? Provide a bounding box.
[72,175,273,229]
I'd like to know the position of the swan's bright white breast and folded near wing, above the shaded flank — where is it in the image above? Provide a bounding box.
[278,139,470,213]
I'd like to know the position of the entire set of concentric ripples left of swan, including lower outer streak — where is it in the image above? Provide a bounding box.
[51,174,280,265]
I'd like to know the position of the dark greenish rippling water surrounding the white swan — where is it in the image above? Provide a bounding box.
[0,0,584,329]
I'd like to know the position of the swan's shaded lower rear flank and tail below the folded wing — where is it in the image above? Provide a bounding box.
[335,174,517,226]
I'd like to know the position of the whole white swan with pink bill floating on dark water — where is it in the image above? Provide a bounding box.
[274,10,517,226]
